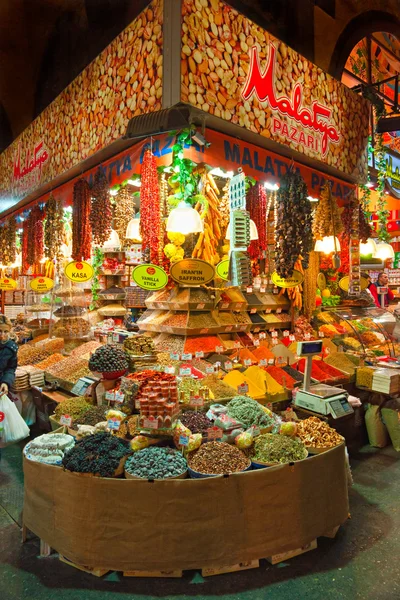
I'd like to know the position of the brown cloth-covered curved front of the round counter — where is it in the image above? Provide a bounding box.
[23,445,349,572]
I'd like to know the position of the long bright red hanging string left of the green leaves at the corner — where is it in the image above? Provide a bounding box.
[140,150,164,266]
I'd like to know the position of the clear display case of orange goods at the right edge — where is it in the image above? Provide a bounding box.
[313,307,396,359]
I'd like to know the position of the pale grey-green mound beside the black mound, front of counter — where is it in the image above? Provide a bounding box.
[125,447,187,479]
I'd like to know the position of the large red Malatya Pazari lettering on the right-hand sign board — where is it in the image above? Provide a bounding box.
[242,44,340,157]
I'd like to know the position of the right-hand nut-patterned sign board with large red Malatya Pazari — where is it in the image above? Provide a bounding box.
[181,0,368,178]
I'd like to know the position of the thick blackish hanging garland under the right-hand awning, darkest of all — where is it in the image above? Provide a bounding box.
[275,170,313,277]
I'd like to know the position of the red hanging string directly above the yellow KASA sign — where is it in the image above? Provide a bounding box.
[72,179,92,260]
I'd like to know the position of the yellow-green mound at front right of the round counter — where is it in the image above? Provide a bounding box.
[253,433,308,464]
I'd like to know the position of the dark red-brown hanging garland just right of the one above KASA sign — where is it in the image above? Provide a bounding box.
[90,170,112,246]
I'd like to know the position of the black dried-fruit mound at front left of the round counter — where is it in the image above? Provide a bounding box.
[62,432,131,477]
